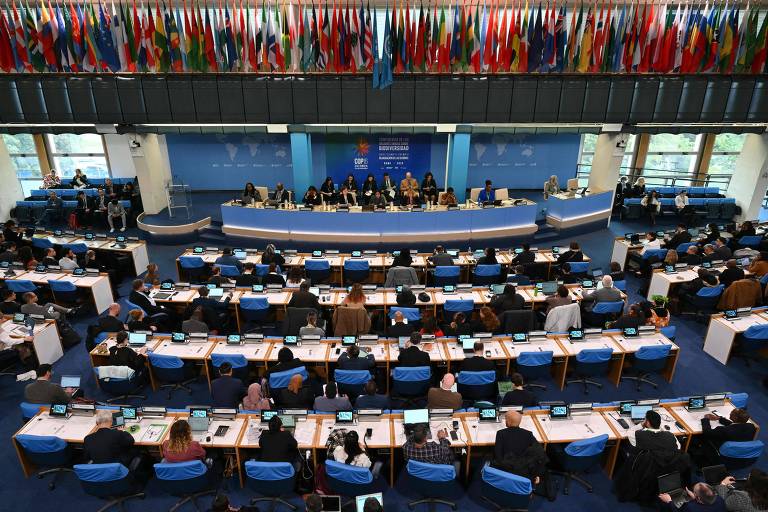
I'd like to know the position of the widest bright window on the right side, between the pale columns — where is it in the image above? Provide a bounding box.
[643,133,704,186]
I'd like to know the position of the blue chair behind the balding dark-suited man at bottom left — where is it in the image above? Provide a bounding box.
[74,463,144,512]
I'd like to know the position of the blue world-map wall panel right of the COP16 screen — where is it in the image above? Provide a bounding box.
[468,134,581,189]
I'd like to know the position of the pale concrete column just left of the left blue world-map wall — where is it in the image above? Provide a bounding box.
[130,134,171,214]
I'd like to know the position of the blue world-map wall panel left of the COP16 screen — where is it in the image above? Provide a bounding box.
[166,134,293,191]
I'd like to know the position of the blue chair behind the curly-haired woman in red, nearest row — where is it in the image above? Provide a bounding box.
[155,460,216,512]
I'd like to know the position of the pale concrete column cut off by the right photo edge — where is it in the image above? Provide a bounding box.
[726,133,768,222]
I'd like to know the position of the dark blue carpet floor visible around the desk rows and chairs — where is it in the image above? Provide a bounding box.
[0,213,768,512]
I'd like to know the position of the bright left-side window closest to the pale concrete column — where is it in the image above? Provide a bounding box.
[46,133,109,178]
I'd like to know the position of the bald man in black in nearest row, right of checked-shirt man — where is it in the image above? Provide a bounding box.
[492,411,548,485]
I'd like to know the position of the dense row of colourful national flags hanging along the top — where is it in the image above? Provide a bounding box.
[0,0,768,87]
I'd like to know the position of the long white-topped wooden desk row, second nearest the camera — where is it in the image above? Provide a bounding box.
[90,331,680,389]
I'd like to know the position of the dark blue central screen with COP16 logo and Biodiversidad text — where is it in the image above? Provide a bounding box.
[312,134,446,186]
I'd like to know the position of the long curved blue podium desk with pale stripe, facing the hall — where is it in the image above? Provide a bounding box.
[221,201,537,243]
